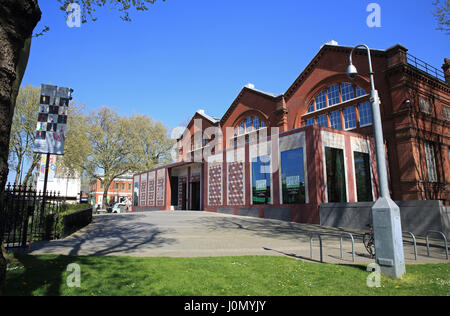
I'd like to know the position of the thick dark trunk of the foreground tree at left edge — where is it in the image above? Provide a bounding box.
[0,0,41,295]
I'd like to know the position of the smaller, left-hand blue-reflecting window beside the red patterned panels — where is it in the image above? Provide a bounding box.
[252,155,270,204]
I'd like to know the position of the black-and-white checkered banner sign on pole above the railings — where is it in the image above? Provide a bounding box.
[33,84,73,155]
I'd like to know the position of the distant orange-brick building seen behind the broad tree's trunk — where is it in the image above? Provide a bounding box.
[89,175,133,206]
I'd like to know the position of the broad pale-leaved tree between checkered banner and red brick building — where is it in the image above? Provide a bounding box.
[57,107,173,206]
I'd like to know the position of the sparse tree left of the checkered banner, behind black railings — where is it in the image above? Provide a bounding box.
[9,85,40,184]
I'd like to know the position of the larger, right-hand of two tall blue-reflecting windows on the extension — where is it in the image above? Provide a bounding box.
[281,148,305,204]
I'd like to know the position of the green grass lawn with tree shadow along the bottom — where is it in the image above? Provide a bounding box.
[6,254,450,296]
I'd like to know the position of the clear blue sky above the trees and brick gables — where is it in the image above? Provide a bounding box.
[10,0,450,185]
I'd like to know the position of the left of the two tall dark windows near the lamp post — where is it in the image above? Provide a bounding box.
[325,147,347,203]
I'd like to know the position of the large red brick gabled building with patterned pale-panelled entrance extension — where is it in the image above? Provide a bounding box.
[134,45,450,228]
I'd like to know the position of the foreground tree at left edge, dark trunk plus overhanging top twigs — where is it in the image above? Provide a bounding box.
[0,0,164,295]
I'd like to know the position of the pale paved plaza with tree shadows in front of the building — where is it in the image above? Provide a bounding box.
[26,211,448,264]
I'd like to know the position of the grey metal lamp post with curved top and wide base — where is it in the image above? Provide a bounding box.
[347,45,406,278]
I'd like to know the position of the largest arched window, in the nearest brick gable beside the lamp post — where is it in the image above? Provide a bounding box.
[302,82,372,130]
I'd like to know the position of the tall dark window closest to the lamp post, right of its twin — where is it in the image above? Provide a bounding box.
[353,151,373,202]
